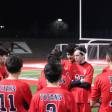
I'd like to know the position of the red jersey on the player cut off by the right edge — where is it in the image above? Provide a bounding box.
[91,70,112,112]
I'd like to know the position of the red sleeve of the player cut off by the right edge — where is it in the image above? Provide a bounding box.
[91,75,101,100]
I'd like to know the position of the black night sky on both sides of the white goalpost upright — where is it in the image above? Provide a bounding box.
[0,0,112,38]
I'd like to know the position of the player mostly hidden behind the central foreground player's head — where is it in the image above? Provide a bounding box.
[37,49,71,90]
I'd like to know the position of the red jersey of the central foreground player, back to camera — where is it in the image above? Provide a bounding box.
[29,87,75,112]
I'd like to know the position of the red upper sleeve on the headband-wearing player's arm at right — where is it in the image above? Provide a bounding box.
[84,66,94,84]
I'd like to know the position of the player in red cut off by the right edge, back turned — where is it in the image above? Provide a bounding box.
[90,45,112,112]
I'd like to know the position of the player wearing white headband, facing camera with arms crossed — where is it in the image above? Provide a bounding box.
[70,47,94,112]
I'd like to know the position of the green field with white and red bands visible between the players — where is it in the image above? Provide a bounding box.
[20,65,105,112]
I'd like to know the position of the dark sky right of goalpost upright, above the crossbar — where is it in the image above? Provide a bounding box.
[82,0,112,39]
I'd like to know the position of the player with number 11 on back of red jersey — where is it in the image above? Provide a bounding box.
[0,55,32,112]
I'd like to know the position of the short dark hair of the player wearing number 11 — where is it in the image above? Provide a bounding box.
[6,54,23,73]
